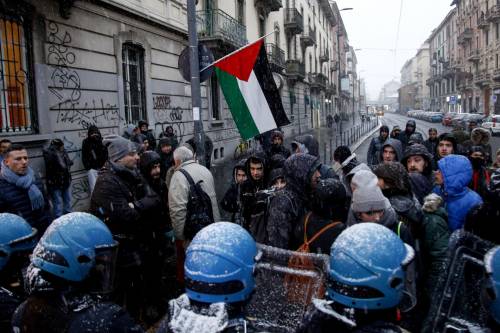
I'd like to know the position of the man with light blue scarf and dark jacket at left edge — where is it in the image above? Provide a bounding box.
[0,144,52,235]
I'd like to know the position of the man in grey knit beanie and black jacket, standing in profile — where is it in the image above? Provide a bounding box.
[90,135,161,316]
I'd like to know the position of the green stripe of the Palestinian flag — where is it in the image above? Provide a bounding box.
[215,67,259,140]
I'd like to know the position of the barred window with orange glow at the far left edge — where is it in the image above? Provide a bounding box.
[0,14,36,134]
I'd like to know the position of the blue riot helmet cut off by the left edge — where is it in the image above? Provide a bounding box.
[0,213,37,270]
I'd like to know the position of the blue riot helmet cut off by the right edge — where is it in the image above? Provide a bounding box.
[484,246,500,324]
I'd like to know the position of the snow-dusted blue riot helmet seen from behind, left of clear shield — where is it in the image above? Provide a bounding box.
[184,222,257,303]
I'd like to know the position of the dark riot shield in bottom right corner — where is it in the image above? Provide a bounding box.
[427,230,493,333]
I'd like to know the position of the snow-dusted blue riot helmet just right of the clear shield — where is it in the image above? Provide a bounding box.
[327,222,414,310]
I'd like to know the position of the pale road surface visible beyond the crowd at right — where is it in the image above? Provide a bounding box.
[355,112,500,162]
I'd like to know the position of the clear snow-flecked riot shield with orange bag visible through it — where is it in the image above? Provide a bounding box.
[245,244,328,332]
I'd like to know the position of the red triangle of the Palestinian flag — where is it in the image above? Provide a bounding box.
[214,39,263,81]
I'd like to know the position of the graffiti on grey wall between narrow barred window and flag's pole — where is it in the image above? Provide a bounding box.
[153,95,188,142]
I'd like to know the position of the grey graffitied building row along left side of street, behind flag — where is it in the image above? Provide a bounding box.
[0,0,348,210]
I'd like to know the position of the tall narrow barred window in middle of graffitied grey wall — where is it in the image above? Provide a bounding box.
[122,44,147,124]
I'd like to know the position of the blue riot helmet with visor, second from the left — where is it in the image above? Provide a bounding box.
[31,213,118,293]
